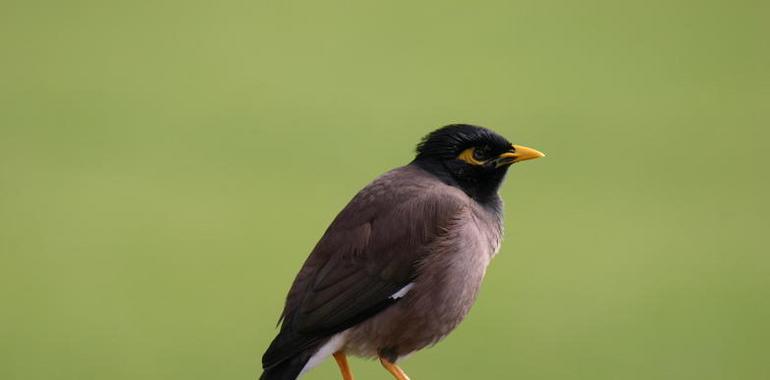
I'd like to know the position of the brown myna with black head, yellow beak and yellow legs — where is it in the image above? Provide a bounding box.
[260,124,544,380]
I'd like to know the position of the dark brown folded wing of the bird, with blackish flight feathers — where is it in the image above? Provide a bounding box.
[262,167,467,368]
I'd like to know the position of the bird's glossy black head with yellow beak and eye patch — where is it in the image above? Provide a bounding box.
[414,124,544,203]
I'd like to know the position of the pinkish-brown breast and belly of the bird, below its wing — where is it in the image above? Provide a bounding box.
[341,167,502,357]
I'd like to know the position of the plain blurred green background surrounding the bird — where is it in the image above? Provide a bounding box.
[0,0,770,380]
